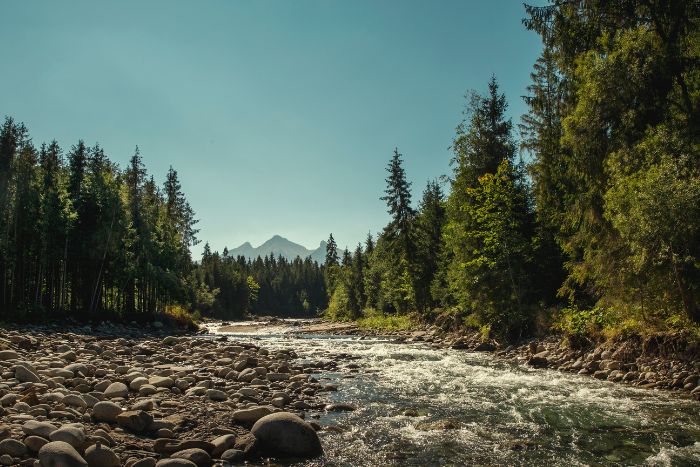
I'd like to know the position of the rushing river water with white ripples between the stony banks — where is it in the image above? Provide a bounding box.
[211,324,700,466]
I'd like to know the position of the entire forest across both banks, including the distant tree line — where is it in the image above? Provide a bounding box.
[0,0,700,339]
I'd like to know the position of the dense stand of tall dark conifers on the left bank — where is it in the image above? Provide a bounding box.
[0,118,197,318]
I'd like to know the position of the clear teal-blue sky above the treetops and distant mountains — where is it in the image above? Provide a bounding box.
[0,0,541,253]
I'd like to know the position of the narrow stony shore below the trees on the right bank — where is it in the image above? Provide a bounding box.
[301,322,700,401]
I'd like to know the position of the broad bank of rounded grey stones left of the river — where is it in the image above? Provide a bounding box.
[0,323,344,467]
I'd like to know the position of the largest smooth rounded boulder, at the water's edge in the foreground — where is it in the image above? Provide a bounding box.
[250,412,323,458]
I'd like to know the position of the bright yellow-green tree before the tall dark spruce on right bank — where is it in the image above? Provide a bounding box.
[445,160,533,334]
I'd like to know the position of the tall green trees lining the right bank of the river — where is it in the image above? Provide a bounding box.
[326,1,700,344]
